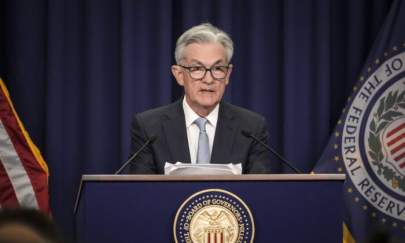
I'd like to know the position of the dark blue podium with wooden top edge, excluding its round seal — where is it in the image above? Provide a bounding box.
[75,174,345,243]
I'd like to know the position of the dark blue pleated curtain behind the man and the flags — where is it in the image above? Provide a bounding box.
[0,0,391,239]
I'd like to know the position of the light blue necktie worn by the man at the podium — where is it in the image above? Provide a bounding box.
[194,117,211,164]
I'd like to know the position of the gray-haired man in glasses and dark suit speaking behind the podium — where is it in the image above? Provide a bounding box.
[130,24,270,174]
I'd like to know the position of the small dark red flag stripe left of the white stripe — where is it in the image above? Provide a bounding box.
[0,161,19,208]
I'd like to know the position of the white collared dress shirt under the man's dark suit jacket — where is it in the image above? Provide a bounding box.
[183,97,219,164]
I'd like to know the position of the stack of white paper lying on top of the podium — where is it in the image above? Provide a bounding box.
[165,162,242,175]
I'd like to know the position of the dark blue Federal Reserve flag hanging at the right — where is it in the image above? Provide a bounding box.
[314,0,405,242]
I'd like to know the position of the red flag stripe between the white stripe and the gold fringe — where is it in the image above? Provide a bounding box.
[0,85,50,212]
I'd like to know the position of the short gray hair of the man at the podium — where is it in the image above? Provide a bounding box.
[174,23,233,64]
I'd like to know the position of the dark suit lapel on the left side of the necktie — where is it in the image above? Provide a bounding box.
[163,99,191,163]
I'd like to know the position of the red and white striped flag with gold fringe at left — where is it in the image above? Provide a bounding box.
[0,79,50,213]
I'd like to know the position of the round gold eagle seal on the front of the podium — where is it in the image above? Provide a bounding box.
[173,189,255,243]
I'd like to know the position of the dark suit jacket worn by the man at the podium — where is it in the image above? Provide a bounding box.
[130,99,270,174]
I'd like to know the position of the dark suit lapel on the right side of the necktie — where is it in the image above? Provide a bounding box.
[211,103,237,163]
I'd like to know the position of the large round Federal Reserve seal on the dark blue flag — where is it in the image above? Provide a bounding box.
[341,52,405,222]
